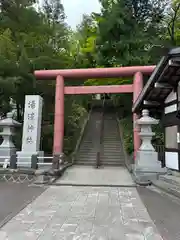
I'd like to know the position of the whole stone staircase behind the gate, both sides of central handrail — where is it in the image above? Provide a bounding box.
[75,108,125,166]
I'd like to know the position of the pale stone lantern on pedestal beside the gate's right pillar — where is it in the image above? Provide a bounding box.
[134,110,166,183]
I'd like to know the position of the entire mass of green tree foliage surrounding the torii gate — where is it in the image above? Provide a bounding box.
[0,0,180,154]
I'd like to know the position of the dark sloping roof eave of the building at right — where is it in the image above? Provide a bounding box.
[132,47,180,113]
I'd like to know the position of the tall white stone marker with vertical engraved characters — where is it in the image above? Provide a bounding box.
[17,95,43,167]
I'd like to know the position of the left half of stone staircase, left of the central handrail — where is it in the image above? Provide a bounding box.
[75,109,101,166]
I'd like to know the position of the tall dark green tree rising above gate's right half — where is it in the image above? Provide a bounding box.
[97,0,168,66]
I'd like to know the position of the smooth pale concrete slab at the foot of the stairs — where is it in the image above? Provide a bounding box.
[56,166,135,187]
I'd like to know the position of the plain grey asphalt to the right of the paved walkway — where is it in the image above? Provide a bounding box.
[137,187,180,240]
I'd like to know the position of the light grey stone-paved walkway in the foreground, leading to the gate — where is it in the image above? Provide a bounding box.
[0,170,162,240]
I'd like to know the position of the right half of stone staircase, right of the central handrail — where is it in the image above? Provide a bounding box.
[100,113,125,166]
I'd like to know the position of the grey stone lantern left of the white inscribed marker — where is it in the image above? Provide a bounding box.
[0,112,21,162]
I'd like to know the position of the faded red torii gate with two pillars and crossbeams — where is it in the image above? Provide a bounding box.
[34,66,155,159]
